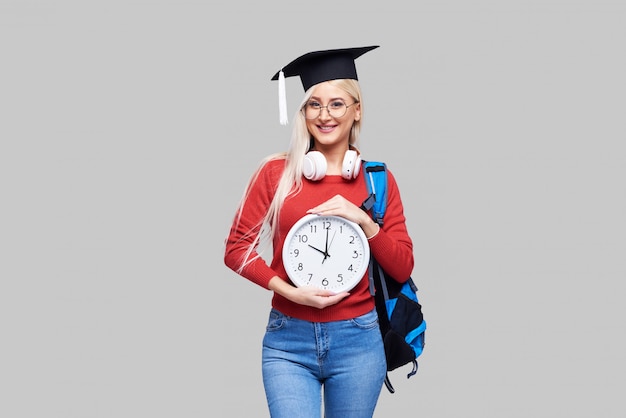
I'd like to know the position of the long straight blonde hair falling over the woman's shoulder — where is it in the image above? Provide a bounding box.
[228,79,363,273]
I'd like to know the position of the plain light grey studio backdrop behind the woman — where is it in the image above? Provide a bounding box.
[0,0,626,418]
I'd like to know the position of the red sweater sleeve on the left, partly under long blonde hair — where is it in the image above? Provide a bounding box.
[224,160,284,289]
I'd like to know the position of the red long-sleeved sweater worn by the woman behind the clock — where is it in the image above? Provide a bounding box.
[224,159,414,322]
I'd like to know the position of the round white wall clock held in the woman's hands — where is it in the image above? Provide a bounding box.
[283,215,370,292]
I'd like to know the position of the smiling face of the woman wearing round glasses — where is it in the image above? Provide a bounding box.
[305,82,361,146]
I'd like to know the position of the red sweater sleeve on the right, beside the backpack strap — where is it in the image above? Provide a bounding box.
[369,170,414,283]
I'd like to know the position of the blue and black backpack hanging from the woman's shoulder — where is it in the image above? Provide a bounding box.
[361,161,426,393]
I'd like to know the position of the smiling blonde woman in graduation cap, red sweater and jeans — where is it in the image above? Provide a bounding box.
[224,46,414,418]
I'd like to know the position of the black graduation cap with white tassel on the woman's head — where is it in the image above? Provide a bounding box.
[272,45,378,125]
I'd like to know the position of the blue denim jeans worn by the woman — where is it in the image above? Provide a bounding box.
[263,309,387,418]
